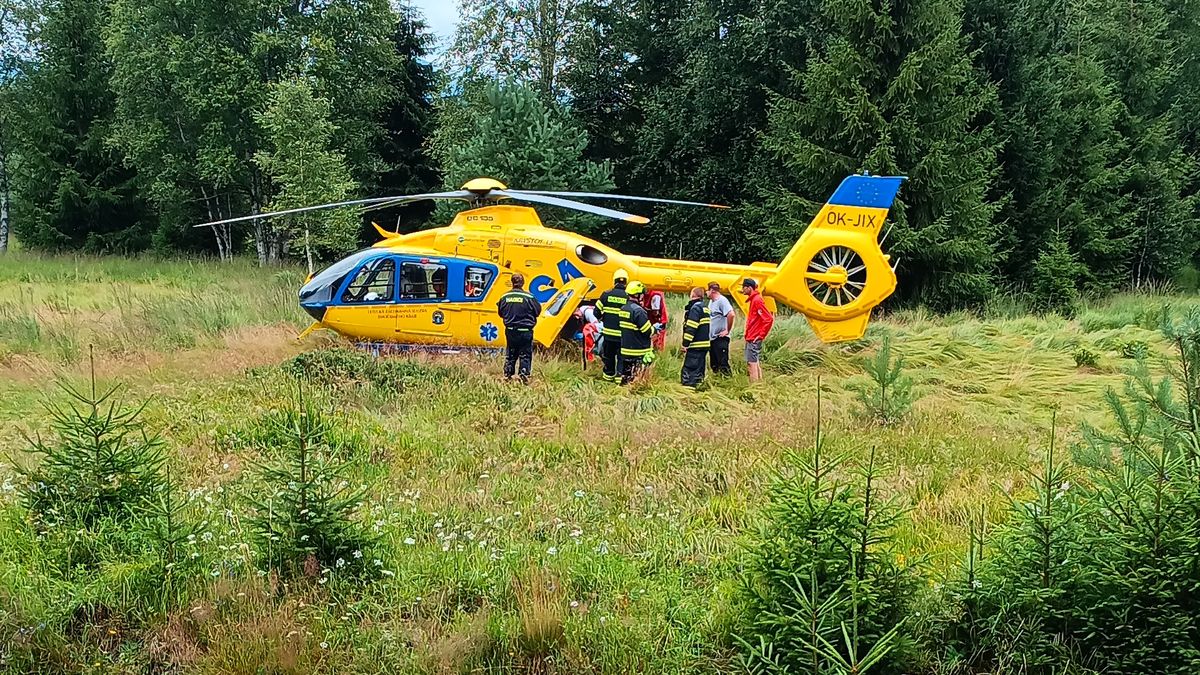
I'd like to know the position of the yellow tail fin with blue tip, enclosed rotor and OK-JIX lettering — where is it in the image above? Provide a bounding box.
[762,174,905,342]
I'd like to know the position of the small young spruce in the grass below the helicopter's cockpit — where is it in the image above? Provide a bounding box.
[248,381,373,578]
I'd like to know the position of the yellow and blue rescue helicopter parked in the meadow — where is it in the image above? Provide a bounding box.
[197,173,905,348]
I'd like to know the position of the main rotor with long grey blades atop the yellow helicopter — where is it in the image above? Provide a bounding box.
[196,178,728,227]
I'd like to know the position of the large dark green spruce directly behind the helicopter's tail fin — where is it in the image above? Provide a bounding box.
[756,0,997,310]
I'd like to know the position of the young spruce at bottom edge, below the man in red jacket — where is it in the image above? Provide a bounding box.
[734,381,917,674]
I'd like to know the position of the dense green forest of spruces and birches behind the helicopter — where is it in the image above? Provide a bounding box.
[0,0,1200,311]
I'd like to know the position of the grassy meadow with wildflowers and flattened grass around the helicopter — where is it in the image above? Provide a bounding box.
[0,253,1200,674]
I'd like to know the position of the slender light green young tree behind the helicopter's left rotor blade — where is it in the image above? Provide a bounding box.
[254,79,359,266]
